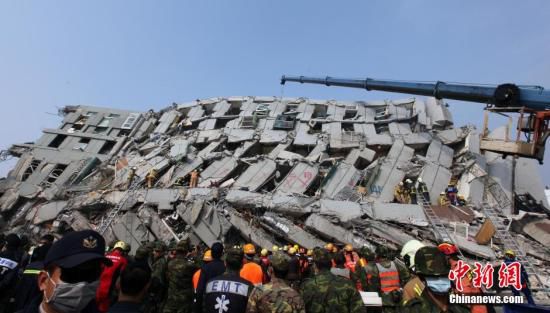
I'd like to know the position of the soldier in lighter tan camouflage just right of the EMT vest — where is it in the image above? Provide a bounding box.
[246,252,305,313]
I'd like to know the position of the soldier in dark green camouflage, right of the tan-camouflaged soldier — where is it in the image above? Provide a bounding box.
[301,249,365,313]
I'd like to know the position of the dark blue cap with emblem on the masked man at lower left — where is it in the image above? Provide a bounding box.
[44,229,112,268]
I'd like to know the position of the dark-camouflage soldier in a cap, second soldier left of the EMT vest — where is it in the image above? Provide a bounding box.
[163,240,197,313]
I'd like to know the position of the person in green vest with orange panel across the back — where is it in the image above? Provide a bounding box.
[369,246,410,312]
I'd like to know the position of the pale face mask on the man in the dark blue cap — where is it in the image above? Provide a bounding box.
[44,274,99,313]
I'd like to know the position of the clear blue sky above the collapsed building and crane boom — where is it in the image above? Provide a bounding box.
[0,0,550,184]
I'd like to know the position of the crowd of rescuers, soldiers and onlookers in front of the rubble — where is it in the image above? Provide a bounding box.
[0,230,532,313]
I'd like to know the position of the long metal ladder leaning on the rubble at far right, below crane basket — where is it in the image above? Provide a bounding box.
[481,203,545,289]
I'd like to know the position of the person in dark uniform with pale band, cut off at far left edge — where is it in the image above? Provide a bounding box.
[0,234,21,312]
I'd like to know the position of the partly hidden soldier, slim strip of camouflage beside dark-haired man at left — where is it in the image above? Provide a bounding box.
[145,241,168,313]
